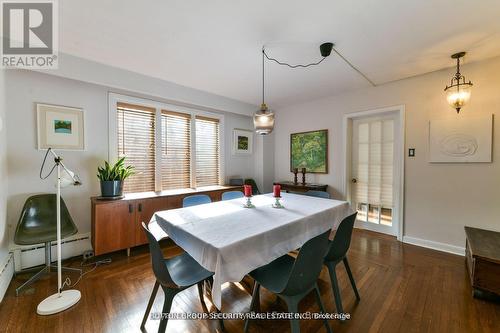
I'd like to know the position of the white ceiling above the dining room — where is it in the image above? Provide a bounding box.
[59,0,500,108]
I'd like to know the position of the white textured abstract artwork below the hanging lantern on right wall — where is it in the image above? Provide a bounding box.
[429,114,493,163]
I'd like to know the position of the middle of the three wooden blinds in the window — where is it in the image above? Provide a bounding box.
[161,110,191,190]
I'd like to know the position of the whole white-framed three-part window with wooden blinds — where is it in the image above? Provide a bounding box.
[114,94,222,193]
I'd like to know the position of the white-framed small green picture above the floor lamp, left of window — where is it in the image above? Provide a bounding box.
[36,103,85,150]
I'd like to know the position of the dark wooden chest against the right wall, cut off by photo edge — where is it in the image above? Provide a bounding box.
[465,227,500,298]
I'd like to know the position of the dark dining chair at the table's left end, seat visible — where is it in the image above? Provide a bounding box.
[141,222,224,332]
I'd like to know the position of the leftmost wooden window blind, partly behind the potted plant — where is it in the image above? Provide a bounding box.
[117,103,156,193]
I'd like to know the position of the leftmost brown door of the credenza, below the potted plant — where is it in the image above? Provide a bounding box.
[92,201,135,255]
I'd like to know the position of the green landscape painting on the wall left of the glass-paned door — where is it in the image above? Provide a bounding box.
[290,129,328,173]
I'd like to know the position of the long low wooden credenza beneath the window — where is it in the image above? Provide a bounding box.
[91,186,243,255]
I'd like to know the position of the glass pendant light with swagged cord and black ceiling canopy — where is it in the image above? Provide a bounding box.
[253,43,333,135]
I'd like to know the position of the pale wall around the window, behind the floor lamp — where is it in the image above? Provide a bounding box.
[4,70,261,245]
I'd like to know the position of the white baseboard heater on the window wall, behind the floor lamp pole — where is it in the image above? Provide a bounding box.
[10,233,92,272]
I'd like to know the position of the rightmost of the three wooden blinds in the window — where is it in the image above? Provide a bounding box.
[195,116,220,187]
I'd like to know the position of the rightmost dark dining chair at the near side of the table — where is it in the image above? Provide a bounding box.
[324,213,361,313]
